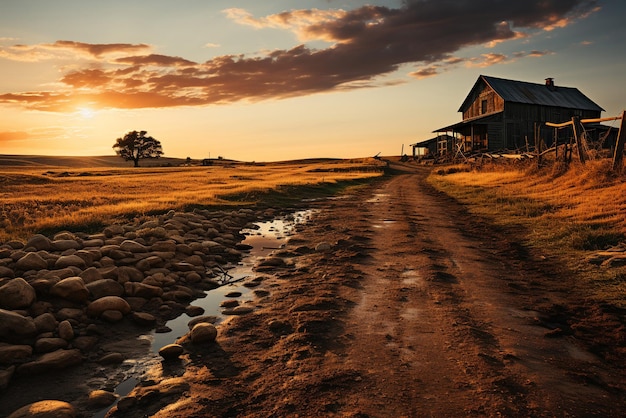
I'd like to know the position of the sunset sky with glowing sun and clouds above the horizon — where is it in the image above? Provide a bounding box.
[0,0,626,162]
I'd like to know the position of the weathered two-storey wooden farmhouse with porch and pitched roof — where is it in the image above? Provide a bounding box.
[426,75,604,155]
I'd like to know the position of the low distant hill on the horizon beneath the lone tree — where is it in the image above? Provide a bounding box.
[0,154,186,168]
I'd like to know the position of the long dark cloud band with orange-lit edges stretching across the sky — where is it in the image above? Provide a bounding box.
[0,0,596,110]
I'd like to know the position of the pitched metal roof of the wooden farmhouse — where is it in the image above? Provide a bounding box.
[459,75,604,112]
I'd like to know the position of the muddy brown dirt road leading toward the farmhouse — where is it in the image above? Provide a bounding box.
[109,169,626,417]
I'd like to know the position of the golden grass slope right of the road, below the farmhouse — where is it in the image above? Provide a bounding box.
[429,161,626,308]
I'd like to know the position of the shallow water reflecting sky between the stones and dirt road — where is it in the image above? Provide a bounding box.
[94,210,313,418]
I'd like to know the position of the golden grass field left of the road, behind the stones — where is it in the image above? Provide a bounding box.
[0,159,382,241]
